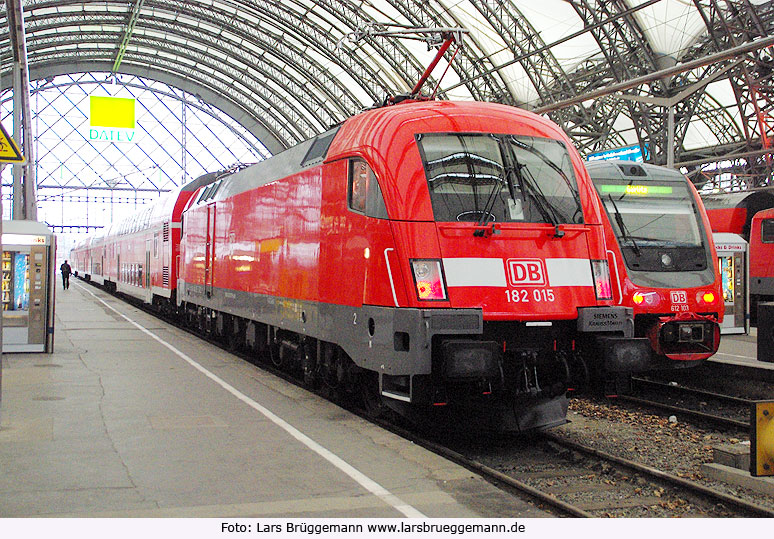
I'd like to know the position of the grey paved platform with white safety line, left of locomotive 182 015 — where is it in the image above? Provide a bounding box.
[0,281,545,518]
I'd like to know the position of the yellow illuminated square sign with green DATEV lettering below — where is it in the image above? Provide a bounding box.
[88,95,137,143]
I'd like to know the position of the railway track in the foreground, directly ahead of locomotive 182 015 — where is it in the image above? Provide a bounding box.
[404,428,774,518]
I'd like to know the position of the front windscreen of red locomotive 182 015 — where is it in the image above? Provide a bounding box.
[417,133,583,224]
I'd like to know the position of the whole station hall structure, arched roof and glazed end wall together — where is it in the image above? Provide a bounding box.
[0,0,774,268]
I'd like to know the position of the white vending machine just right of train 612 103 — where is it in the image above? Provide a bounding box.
[712,232,750,334]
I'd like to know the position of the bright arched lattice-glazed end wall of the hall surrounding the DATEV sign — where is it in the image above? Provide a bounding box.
[0,73,269,232]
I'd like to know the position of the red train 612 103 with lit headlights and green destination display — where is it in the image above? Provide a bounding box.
[586,161,723,388]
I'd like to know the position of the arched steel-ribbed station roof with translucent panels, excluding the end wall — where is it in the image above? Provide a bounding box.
[0,0,774,173]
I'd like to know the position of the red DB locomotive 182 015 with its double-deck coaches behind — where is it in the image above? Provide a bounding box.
[71,101,656,430]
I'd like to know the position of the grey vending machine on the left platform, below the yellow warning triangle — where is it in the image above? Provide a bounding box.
[1,221,56,353]
